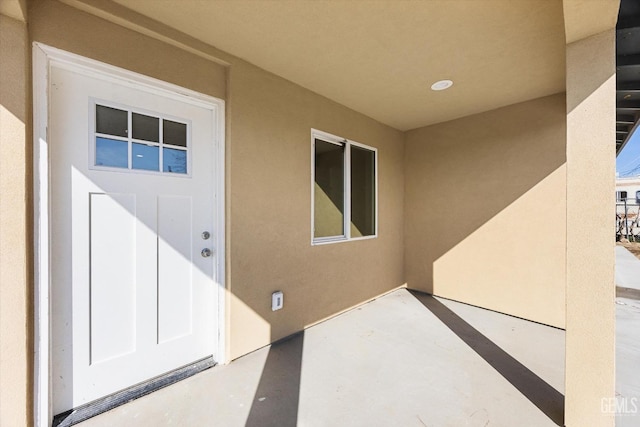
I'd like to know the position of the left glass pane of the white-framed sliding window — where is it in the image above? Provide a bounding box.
[314,139,345,237]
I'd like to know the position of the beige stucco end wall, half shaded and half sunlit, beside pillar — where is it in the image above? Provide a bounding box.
[405,94,566,327]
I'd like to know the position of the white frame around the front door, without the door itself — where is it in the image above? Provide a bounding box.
[32,42,227,426]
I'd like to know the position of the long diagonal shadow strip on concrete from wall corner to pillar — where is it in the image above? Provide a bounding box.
[409,291,564,426]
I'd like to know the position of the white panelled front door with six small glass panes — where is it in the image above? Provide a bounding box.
[49,64,220,414]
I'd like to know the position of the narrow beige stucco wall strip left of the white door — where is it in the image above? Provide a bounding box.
[0,11,32,426]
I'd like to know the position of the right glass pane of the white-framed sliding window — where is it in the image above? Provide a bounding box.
[351,145,376,237]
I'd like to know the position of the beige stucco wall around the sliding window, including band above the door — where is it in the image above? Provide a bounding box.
[29,0,404,359]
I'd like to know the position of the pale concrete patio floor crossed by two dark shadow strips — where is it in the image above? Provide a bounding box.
[79,289,565,427]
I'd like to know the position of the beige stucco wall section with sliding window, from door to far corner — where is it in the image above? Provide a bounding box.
[228,61,403,358]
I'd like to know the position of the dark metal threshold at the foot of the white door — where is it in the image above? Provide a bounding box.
[52,356,216,427]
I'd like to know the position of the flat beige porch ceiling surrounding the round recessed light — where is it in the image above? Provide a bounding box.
[107,0,565,130]
